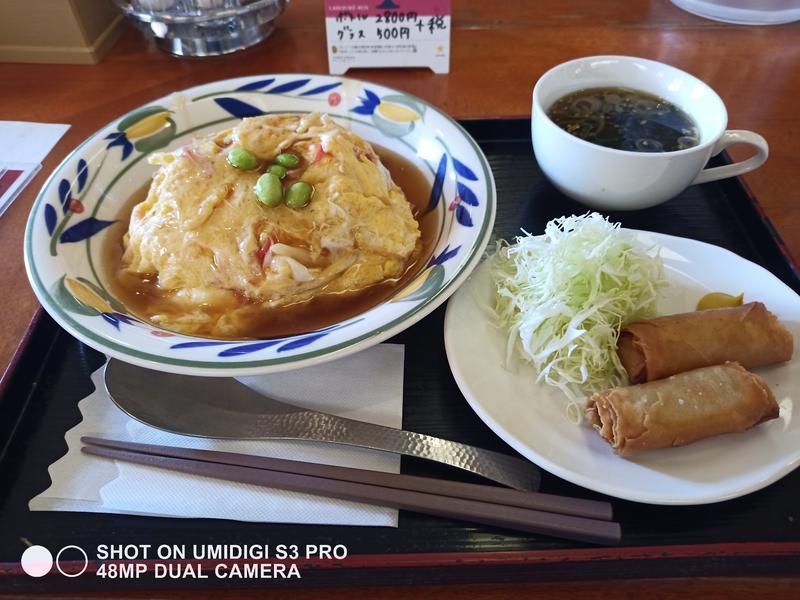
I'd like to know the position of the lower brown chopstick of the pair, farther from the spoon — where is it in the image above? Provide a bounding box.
[81,438,621,544]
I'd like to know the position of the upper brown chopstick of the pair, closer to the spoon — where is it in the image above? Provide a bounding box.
[81,437,612,521]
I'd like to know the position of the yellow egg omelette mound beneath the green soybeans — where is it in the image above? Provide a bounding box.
[122,114,420,337]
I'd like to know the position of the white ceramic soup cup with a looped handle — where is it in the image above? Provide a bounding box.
[531,56,769,210]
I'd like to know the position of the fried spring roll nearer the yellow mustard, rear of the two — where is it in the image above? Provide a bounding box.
[617,302,794,383]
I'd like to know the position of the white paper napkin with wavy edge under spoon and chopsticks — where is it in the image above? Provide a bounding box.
[29,344,403,527]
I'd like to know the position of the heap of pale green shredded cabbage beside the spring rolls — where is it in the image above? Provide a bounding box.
[491,213,666,401]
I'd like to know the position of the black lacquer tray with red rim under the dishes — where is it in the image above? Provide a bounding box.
[0,119,800,592]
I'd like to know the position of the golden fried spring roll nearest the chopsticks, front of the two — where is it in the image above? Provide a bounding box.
[586,363,778,454]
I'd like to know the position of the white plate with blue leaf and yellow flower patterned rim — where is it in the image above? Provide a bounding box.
[25,74,495,376]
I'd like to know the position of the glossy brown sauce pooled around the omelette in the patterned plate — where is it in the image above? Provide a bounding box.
[105,146,439,339]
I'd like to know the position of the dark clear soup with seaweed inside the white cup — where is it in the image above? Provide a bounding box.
[547,87,700,152]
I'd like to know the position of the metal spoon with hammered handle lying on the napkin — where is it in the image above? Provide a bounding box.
[100,359,540,491]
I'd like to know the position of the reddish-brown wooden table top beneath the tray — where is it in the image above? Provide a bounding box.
[0,0,800,598]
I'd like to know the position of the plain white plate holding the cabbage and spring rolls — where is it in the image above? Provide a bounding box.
[445,232,800,504]
